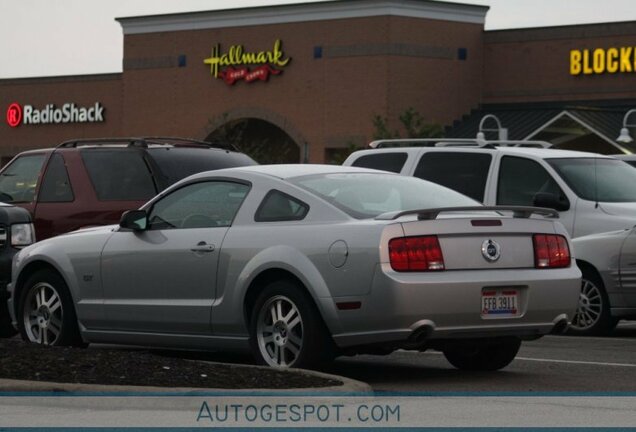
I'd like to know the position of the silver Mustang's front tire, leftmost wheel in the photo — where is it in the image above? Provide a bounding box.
[16,270,84,346]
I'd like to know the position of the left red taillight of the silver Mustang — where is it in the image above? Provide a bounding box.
[389,236,444,271]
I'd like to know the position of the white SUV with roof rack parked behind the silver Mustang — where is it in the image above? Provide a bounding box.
[344,139,636,237]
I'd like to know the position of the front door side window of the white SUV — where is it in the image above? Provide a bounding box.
[497,156,564,206]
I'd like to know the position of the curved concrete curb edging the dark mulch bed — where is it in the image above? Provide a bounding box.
[0,361,373,395]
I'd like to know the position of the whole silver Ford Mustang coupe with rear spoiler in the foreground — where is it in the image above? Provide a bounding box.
[10,165,581,370]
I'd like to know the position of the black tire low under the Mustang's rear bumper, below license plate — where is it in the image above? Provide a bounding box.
[443,338,521,371]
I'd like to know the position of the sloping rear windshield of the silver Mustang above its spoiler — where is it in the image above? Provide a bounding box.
[290,170,476,219]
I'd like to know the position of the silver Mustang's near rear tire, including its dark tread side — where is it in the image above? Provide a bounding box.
[249,280,334,369]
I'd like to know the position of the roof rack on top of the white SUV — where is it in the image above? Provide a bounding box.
[369,138,552,149]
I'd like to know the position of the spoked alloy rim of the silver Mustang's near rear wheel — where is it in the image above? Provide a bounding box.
[256,295,303,367]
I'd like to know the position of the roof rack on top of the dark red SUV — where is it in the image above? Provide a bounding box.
[57,136,239,151]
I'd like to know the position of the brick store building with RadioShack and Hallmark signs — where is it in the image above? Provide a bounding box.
[0,0,636,163]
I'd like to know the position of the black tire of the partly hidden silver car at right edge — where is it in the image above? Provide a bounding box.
[568,266,618,336]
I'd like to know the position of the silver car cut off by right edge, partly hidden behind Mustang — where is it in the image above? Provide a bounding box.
[570,228,636,335]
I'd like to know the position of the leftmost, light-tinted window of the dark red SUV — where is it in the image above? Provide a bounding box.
[0,154,46,202]
